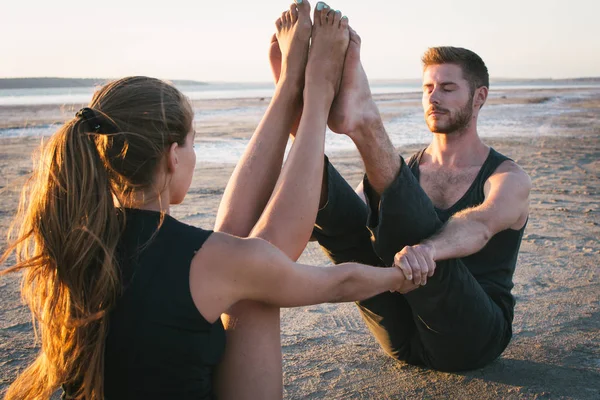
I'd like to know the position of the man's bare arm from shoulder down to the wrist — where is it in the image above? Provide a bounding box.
[423,161,531,261]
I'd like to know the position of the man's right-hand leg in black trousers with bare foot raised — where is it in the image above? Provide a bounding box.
[328,21,510,370]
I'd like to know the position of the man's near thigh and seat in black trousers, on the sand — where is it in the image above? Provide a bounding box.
[404,260,512,371]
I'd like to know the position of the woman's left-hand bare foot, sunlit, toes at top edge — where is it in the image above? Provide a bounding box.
[269,0,312,87]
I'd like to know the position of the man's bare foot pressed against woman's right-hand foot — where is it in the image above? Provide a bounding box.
[327,28,380,135]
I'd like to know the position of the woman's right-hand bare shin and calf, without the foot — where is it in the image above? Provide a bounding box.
[251,88,333,259]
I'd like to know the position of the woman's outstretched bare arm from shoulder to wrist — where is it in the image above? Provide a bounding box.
[190,232,410,322]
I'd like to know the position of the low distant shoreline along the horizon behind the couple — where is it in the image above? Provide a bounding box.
[0,77,600,90]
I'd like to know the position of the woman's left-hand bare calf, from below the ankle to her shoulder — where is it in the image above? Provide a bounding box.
[215,82,301,236]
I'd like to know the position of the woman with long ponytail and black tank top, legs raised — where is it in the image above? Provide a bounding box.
[2,2,405,399]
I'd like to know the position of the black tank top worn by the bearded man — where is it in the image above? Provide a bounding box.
[407,148,525,325]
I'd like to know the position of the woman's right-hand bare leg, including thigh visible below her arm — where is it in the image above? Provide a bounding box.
[216,2,348,399]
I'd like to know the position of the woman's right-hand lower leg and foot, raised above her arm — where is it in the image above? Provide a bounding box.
[252,4,349,259]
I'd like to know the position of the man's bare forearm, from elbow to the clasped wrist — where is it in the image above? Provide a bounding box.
[423,209,492,261]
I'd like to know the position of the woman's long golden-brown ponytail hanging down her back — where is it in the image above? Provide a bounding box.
[0,114,123,399]
